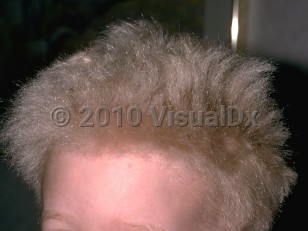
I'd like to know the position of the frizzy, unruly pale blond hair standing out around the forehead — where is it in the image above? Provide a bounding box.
[1,20,296,231]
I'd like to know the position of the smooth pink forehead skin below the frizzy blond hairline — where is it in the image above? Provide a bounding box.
[42,149,202,231]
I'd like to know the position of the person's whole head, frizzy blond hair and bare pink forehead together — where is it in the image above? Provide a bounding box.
[1,21,296,231]
